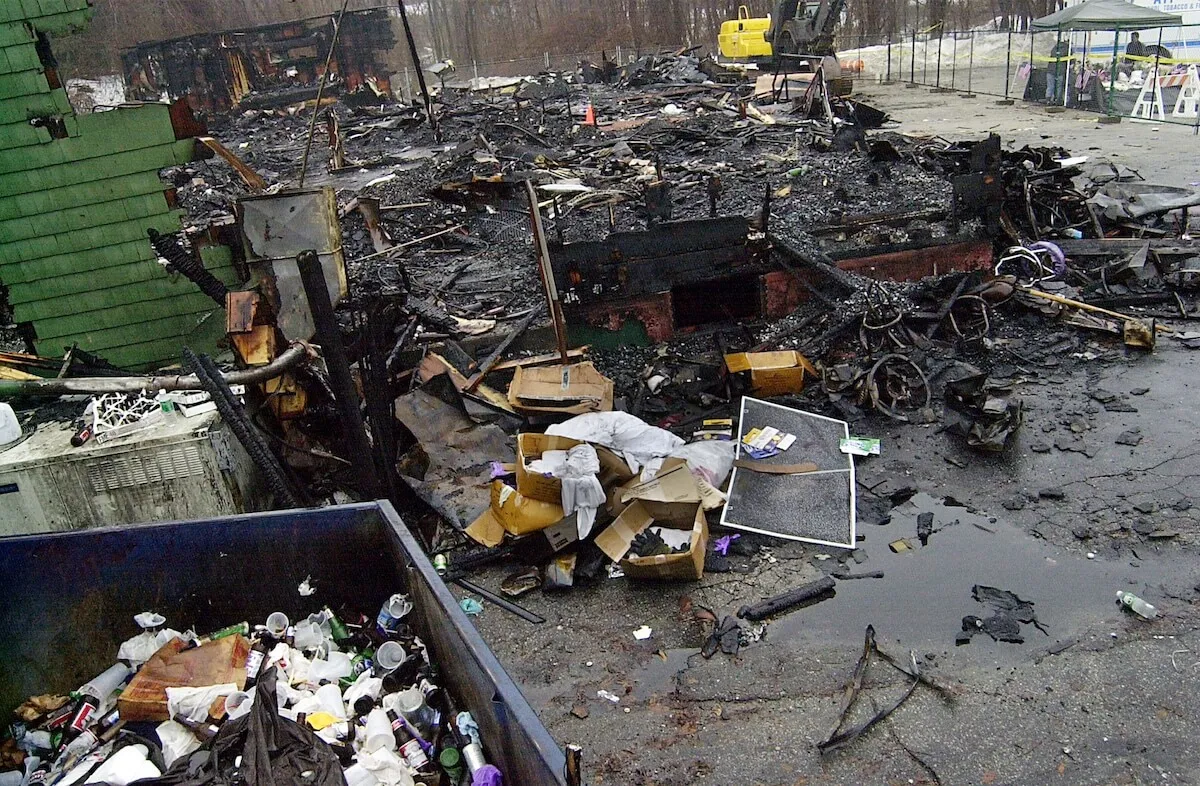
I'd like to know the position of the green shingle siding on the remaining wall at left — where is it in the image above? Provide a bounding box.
[0,0,238,370]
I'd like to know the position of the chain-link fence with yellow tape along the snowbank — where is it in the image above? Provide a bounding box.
[839,25,1200,134]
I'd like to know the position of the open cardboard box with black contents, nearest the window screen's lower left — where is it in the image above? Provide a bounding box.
[596,499,708,581]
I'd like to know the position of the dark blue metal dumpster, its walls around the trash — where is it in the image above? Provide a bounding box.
[0,502,565,786]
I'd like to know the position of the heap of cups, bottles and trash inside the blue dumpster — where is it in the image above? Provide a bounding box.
[0,594,511,786]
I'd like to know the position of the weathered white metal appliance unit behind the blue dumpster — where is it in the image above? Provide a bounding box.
[0,412,270,536]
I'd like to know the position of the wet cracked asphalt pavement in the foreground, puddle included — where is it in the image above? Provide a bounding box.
[453,90,1200,786]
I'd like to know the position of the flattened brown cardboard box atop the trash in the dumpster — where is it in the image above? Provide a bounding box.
[116,635,250,722]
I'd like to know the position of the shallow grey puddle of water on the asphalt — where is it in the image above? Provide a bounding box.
[767,493,1194,661]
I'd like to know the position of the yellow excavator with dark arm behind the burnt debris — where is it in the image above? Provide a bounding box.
[719,0,846,65]
